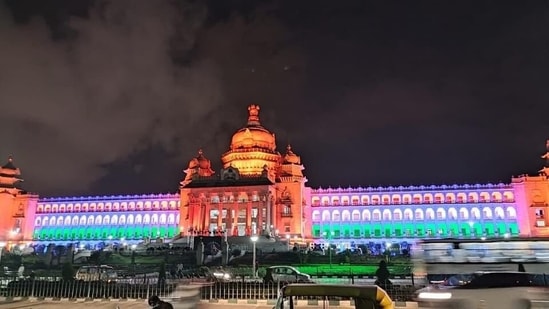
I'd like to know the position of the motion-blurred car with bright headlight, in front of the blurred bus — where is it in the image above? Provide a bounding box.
[416,272,549,309]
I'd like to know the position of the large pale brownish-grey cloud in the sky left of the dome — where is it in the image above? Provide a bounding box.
[0,1,223,192]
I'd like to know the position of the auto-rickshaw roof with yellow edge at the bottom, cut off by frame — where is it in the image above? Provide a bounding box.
[273,284,395,309]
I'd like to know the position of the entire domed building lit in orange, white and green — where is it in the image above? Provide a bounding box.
[0,105,549,244]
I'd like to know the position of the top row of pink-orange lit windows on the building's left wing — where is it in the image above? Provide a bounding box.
[36,200,179,213]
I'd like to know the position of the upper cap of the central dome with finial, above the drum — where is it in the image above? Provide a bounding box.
[231,104,276,152]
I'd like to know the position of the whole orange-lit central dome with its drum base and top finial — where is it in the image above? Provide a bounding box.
[221,104,281,176]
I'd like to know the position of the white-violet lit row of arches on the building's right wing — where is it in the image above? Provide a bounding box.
[312,206,517,222]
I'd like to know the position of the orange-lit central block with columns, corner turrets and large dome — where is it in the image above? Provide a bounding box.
[180,105,311,238]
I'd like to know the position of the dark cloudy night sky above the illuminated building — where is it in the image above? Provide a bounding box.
[0,0,549,196]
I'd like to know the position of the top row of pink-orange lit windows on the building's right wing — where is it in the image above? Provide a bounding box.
[311,191,515,206]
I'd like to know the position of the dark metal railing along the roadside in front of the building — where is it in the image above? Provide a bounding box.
[0,278,415,301]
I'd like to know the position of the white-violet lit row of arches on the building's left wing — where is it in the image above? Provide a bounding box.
[34,213,179,226]
